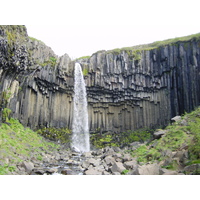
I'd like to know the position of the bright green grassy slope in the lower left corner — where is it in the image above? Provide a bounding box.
[0,118,58,174]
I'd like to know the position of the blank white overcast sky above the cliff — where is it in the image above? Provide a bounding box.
[1,0,200,58]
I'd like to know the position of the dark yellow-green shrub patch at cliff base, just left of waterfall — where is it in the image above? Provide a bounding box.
[37,127,71,143]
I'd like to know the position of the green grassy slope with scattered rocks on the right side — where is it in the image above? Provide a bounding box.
[131,108,200,173]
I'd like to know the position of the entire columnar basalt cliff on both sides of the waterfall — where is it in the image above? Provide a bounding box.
[0,26,200,132]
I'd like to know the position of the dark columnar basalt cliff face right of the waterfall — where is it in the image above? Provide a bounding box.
[77,40,200,131]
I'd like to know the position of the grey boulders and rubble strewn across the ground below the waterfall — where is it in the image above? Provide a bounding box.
[6,142,197,175]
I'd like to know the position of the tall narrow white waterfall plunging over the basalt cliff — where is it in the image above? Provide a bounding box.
[71,63,90,152]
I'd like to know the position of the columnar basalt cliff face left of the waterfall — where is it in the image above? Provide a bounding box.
[0,26,73,128]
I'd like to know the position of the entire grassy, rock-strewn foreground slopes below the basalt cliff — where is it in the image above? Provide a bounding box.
[0,108,200,175]
